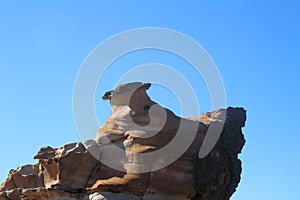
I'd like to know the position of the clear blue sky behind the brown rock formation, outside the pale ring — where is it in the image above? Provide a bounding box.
[0,0,300,200]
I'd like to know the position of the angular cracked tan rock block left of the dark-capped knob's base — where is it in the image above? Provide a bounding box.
[35,143,123,192]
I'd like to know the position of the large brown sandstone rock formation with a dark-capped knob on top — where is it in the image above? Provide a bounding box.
[0,83,246,200]
